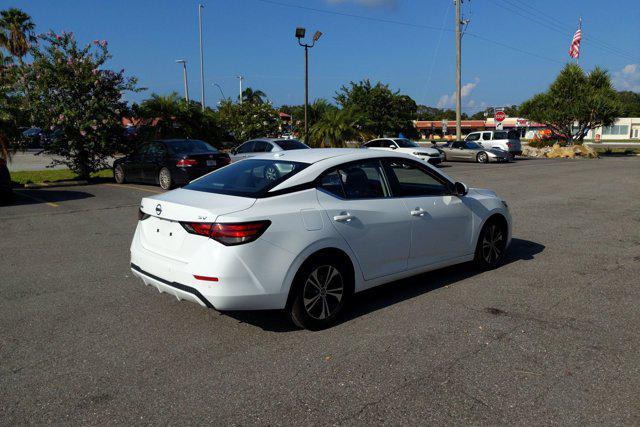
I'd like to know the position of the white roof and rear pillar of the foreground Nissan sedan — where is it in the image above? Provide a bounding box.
[251,148,450,192]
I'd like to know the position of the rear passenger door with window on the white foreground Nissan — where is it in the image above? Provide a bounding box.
[317,160,411,280]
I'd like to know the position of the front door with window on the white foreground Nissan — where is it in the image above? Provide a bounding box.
[384,159,473,269]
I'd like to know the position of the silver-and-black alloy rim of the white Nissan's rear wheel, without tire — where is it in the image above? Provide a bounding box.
[302,265,344,320]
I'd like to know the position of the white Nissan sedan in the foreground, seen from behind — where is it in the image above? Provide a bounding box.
[131,149,511,329]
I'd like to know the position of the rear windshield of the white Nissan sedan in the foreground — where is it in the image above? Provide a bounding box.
[184,159,309,198]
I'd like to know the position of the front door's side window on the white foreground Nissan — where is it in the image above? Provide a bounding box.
[385,159,449,197]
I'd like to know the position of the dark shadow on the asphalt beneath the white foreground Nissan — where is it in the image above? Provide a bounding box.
[225,238,545,332]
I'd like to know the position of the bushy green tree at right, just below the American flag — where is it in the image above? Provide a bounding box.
[520,64,620,143]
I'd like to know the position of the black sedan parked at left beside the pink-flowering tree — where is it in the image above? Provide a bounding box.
[113,139,230,190]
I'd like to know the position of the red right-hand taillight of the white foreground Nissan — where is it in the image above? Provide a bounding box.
[181,221,271,246]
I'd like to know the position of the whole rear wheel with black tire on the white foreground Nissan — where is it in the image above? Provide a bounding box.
[288,255,353,330]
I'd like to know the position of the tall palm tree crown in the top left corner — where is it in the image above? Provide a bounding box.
[0,7,36,65]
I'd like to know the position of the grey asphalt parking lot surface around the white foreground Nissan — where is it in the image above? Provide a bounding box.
[0,157,640,425]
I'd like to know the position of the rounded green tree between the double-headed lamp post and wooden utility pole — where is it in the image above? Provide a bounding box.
[335,79,417,136]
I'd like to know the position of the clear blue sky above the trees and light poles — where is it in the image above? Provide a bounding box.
[8,0,640,112]
